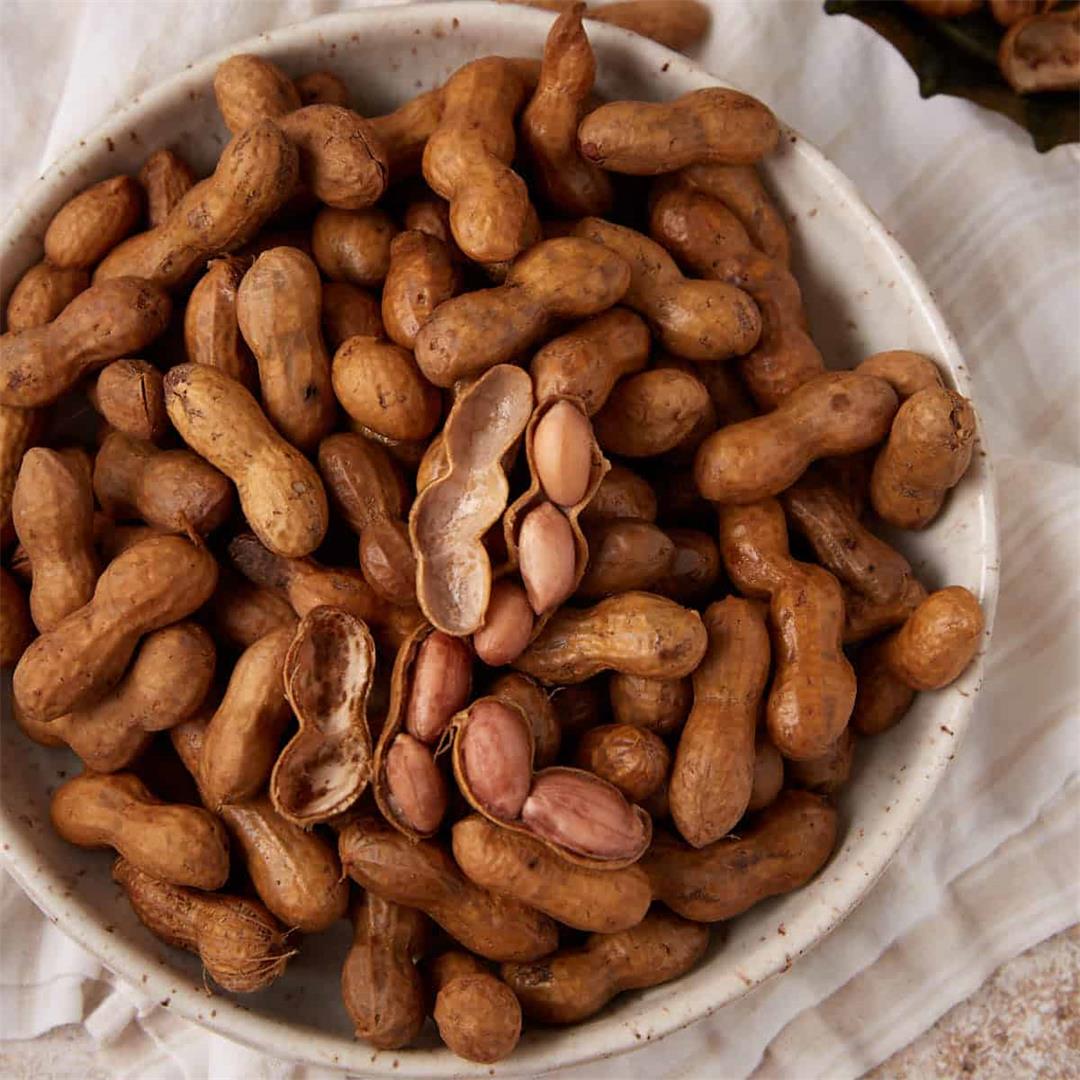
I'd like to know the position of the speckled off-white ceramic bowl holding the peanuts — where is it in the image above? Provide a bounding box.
[0,2,998,1077]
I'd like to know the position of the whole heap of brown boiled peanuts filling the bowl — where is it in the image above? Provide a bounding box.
[0,4,983,1062]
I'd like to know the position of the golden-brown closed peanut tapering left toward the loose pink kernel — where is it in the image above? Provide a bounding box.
[514,593,705,686]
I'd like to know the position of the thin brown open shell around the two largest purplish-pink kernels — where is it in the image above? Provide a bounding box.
[449,696,652,870]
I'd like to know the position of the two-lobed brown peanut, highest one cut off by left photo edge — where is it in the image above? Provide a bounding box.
[0,278,172,408]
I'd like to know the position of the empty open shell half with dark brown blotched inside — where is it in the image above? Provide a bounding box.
[270,607,375,828]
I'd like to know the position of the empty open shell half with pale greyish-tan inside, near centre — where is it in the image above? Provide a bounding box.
[408,364,532,637]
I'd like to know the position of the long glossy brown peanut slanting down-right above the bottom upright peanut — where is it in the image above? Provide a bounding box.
[338,818,558,960]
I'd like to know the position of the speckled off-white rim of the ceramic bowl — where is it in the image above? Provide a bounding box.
[0,0,1000,1077]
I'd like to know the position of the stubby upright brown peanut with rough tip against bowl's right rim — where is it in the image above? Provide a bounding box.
[870,387,975,529]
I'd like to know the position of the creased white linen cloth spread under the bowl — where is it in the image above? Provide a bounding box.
[0,0,1080,1080]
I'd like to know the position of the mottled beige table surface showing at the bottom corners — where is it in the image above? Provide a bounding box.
[0,926,1080,1080]
